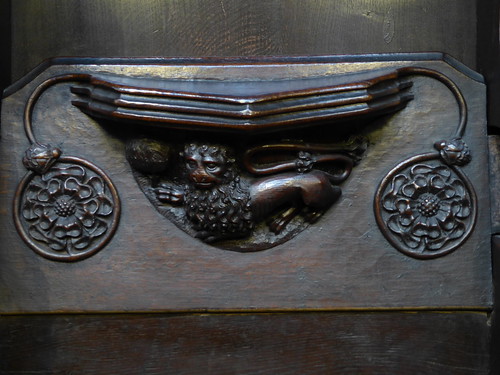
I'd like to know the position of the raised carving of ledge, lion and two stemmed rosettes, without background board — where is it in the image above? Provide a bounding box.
[8,56,476,260]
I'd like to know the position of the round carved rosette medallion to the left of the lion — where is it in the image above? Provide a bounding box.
[14,157,120,261]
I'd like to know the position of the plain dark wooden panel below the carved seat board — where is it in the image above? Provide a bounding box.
[0,312,489,375]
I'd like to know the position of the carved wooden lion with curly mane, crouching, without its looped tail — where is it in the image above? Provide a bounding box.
[154,143,341,243]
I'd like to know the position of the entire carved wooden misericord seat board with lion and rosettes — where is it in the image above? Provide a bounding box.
[0,54,491,318]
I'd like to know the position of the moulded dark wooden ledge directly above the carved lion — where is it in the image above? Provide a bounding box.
[72,70,411,133]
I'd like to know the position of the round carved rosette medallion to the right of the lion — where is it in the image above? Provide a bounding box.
[375,154,477,259]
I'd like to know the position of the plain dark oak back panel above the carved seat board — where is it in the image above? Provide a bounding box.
[12,0,476,80]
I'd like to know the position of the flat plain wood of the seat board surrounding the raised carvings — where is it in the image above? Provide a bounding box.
[0,55,492,313]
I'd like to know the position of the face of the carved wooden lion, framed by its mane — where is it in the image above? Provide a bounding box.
[183,144,232,189]
